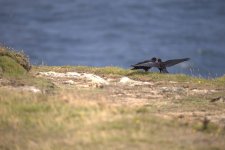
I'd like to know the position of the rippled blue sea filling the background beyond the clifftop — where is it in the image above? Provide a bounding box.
[0,0,225,77]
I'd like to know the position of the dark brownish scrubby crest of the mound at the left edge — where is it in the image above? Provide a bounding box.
[0,46,31,71]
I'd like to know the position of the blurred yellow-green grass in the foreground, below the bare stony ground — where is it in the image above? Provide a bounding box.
[0,89,225,150]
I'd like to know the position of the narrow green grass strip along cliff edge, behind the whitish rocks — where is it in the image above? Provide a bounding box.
[31,66,225,88]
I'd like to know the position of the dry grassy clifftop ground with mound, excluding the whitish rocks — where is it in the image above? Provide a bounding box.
[0,47,225,150]
